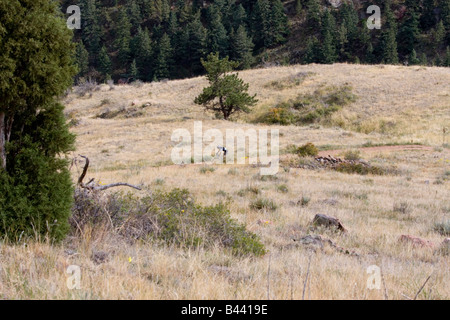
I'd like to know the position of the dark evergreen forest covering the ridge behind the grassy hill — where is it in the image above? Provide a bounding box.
[61,0,450,81]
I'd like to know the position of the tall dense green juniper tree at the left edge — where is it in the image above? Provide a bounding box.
[0,0,77,240]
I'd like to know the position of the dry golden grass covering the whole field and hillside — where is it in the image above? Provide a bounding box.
[0,64,450,299]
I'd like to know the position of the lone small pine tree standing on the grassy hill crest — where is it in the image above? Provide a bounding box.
[194,53,258,120]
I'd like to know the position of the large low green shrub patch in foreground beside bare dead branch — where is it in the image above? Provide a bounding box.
[70,189,266,256]
